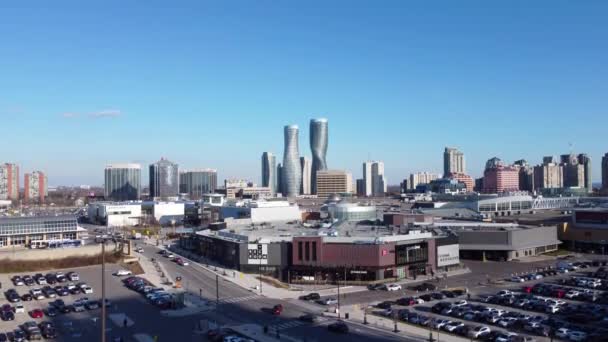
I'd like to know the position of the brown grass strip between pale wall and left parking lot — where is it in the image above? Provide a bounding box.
[0,252,122,273]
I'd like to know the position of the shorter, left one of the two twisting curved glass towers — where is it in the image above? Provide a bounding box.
[281,125,302,197]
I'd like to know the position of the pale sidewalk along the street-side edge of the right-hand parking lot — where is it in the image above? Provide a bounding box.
[332,305,470,342]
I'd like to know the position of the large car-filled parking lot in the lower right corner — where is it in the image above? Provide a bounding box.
[350,262,608,342]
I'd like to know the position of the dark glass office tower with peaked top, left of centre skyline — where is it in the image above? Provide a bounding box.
[150,158,179,199]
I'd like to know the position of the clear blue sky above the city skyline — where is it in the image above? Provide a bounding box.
[0,0,608,185]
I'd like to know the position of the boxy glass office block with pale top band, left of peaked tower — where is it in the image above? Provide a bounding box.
[104,164,141,201]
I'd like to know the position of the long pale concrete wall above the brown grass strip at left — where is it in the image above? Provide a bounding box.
[0,245,101,261]
